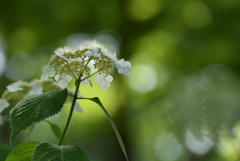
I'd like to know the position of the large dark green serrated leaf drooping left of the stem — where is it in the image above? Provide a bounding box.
[10,89,68,144]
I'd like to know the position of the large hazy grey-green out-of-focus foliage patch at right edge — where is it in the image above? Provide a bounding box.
[167,64,240,142]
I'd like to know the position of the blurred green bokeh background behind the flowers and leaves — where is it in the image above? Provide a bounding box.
[0,0,240,161]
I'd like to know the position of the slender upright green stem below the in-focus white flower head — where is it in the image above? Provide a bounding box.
[58,74,82,146]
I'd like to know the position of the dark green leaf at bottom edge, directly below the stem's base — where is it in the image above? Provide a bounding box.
[32,143,90,161]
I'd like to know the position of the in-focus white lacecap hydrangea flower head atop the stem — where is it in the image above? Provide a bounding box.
[41,42,131,89]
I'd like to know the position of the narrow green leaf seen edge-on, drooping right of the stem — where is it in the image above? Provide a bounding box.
[89,97,128,161]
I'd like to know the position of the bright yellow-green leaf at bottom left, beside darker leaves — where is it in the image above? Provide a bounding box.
[6,141,39,161]
